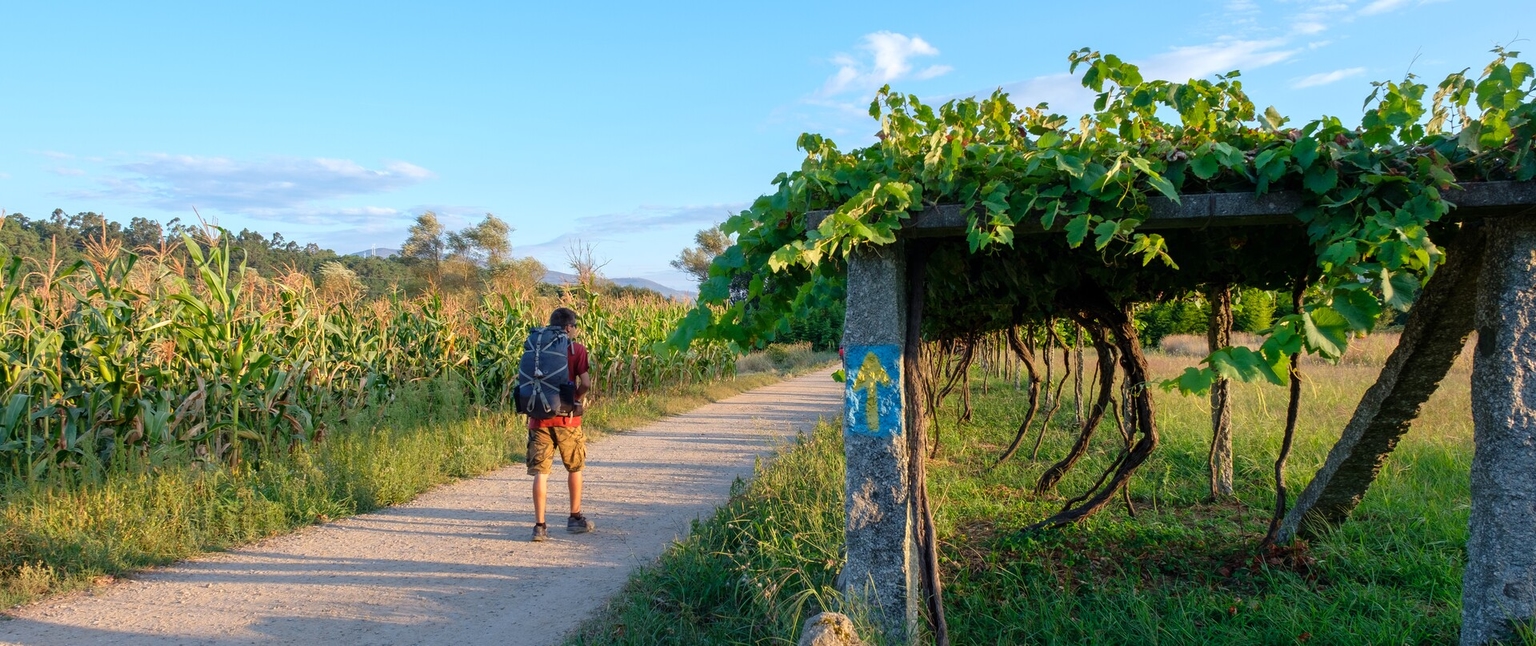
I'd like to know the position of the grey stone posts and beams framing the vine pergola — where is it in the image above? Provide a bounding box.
[808,181,1536,641]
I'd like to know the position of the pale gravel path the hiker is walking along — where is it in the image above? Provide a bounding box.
[0,370,842,644]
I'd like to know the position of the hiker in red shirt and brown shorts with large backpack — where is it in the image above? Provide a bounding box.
[515,307,593,542]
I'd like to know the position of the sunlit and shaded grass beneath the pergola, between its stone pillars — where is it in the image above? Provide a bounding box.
[931,342,1471,644]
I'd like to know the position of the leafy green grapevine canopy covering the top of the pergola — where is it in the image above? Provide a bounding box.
[674,48,1536,382]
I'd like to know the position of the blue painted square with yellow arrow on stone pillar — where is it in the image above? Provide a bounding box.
[843,344,902,437]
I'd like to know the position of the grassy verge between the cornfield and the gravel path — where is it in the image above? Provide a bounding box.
[0,345,829,608]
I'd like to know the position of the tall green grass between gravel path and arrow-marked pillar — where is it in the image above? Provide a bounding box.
[568,424,872,644]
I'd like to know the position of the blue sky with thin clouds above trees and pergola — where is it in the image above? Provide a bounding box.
[0,0,1536,287]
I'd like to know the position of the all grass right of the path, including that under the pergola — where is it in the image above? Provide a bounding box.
[573,339,1471,644]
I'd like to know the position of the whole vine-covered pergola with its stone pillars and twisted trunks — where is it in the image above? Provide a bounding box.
[674,48,1536,644]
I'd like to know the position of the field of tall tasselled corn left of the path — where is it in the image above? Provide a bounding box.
[0,233,734,480]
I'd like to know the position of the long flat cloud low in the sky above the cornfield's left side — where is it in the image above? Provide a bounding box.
[72,153,433,221]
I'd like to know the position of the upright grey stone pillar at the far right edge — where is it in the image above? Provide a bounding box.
[1461,216,1536,646]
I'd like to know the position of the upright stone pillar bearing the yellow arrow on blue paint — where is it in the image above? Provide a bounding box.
[840,244,922,644]
